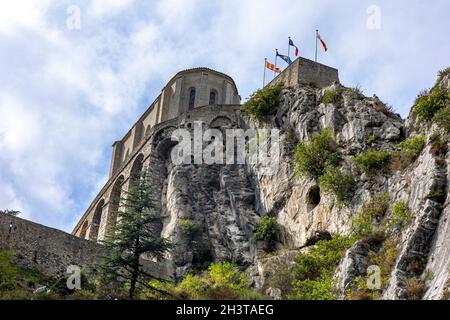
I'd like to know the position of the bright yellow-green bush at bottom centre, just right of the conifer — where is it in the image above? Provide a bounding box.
[175,262,260,300]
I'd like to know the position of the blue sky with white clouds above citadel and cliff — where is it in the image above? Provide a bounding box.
[0,0,450,232]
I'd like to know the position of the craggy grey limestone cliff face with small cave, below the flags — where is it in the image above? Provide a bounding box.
[157,69,450,299]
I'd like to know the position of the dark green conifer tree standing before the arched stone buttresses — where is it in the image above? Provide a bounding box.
[100,168,172,299]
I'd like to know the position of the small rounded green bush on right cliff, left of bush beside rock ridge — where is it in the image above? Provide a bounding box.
[353,149,391,177]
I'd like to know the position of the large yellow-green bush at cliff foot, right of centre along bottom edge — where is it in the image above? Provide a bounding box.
[289,236,355,300]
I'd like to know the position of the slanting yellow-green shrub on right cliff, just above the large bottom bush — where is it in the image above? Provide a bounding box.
[351,193,390,238]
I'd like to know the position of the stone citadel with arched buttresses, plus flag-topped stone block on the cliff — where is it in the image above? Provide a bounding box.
[72,58,339,241]
